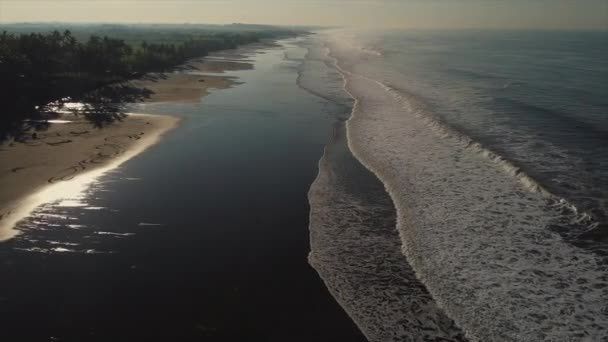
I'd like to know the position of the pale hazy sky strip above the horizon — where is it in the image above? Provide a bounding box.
[0,0,608,30]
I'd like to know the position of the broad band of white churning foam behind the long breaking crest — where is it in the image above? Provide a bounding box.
[327,32,608,341]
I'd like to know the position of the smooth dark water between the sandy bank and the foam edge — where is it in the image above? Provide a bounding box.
[0,38,365,341]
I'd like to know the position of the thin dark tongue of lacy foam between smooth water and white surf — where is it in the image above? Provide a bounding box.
[309,123,465,342]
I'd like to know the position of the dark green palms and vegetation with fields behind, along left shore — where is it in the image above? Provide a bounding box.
[0,25,304,139]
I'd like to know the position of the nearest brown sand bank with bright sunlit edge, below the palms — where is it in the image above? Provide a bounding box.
[0,114,179,241]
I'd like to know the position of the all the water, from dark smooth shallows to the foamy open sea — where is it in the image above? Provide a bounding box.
[0,30,608,342]
